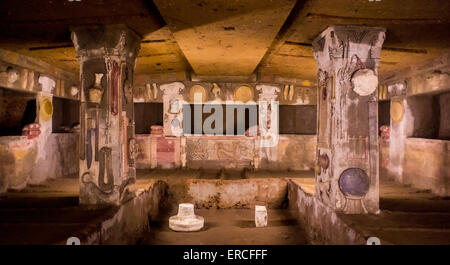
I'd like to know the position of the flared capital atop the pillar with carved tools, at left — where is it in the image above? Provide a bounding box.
[71,24,141,65]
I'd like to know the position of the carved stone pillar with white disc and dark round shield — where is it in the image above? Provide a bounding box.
[313,26,385,213]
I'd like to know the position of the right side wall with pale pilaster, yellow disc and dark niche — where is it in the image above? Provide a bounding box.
[380,54,450,196]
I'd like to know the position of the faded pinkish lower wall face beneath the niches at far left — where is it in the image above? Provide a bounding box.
[0,133,78,193]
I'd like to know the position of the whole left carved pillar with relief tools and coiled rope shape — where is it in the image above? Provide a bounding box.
[72,25,141,205]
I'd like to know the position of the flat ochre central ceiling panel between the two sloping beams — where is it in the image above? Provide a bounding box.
[154,0,296,76]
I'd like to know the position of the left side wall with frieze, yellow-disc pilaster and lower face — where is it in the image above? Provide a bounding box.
[0,49,79,193]
